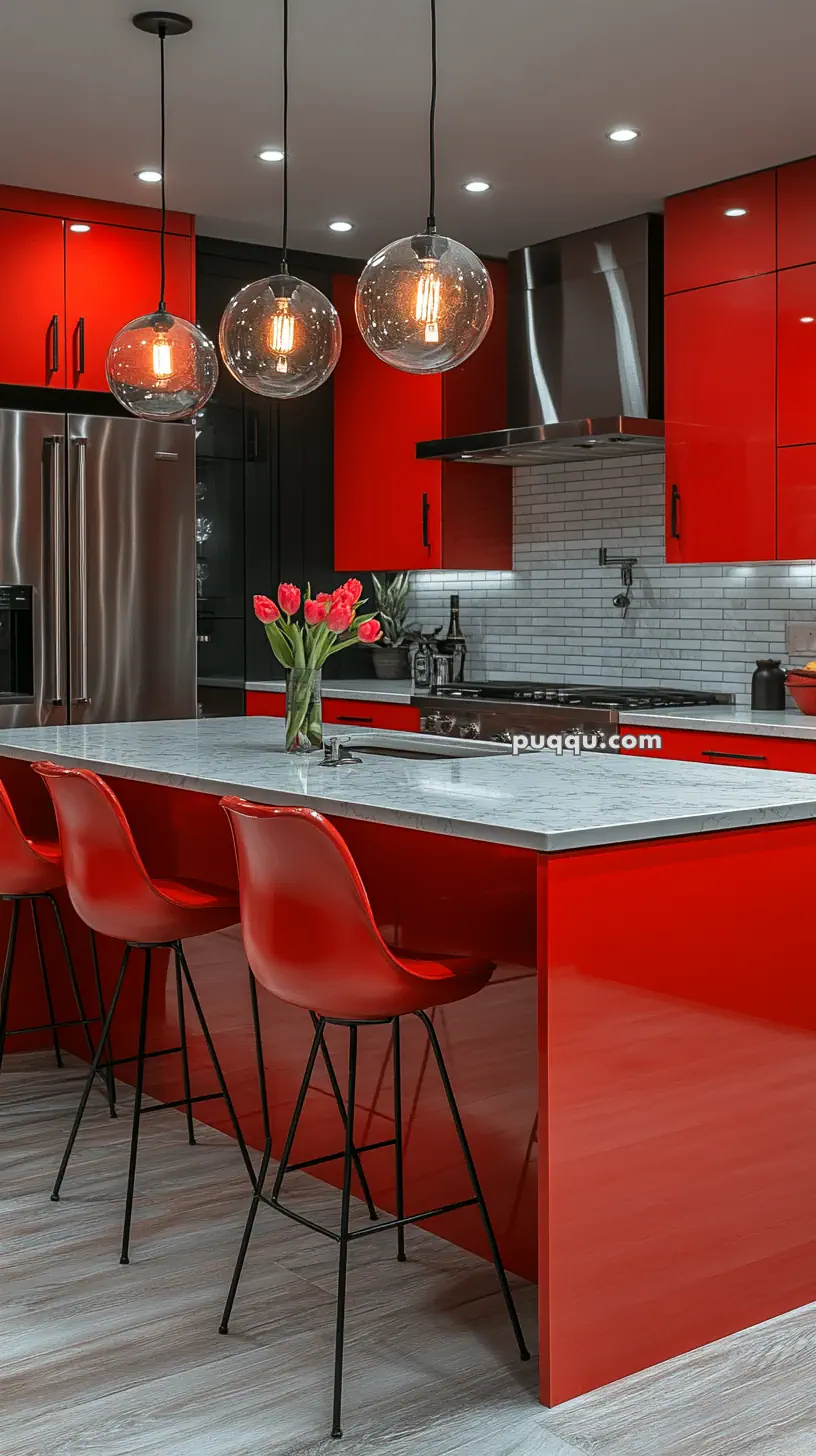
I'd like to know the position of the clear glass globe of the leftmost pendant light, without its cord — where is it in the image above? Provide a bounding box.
[105,313,219,419]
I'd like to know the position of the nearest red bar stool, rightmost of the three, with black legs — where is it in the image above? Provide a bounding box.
[220,798,530,1436]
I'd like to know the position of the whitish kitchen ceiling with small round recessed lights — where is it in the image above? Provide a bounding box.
[0,0,816,256]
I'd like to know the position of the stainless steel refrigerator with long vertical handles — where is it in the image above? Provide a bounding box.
[0,409,195,728]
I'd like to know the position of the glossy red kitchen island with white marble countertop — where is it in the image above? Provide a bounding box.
[0,719,816,1405]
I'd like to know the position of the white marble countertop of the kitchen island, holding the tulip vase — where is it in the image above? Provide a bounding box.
[0,718,816,852]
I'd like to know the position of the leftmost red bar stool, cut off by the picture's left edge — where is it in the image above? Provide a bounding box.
[0,783,117,1117]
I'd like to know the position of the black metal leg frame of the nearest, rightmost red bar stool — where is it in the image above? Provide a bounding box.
[219,1010,530,1437]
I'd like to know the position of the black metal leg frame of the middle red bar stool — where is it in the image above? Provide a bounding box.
[51,941,377,1264]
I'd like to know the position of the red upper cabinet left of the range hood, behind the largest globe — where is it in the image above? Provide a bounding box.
[332,264,513,571]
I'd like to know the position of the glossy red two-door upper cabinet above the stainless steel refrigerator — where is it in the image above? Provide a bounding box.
[0,186,195,390]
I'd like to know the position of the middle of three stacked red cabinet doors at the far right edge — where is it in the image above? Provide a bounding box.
[777,264,816,446]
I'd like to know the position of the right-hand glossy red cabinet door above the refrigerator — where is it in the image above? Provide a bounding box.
[66,223,192,389]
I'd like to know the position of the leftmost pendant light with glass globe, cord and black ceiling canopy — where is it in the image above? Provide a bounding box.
[105,10,219,419]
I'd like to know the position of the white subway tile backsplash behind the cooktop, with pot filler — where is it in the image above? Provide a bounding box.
[412,456,816,703]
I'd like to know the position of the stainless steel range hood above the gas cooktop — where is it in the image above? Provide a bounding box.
[417,213,664,466]
